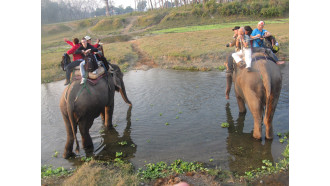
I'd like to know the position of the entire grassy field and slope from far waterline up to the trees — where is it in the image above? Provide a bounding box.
[41,9,289,83]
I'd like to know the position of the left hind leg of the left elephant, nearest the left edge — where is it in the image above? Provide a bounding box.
[62,114,74,159]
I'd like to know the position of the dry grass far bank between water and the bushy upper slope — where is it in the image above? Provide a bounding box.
[41,15,289,83]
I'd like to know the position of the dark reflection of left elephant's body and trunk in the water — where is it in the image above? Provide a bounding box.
[95,107,137,160]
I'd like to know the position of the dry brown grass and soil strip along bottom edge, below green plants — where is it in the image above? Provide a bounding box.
[41,160,289,186]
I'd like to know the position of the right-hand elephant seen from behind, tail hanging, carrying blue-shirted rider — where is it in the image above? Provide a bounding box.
[226,53,282,139]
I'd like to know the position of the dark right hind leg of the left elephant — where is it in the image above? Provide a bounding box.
[79,118,93,149]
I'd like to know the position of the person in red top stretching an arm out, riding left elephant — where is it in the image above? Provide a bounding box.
[64,38,83,85]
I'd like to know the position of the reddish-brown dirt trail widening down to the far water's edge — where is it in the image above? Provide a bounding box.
[131,40,158,70]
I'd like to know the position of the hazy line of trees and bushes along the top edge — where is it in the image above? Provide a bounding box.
[41,0,289,24]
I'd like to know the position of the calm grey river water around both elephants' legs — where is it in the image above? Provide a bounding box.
[41,63,289,174]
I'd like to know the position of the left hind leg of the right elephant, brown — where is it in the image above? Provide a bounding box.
[247,97,263,139]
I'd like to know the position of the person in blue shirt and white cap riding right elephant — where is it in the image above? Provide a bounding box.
[251,21,284,65]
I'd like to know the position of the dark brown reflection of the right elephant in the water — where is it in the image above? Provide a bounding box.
[226,103,273,175]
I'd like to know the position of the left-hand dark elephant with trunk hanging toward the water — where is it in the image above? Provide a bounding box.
[60,64,132,159]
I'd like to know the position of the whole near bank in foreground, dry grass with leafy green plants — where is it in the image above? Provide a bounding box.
[41,142,289,186]
